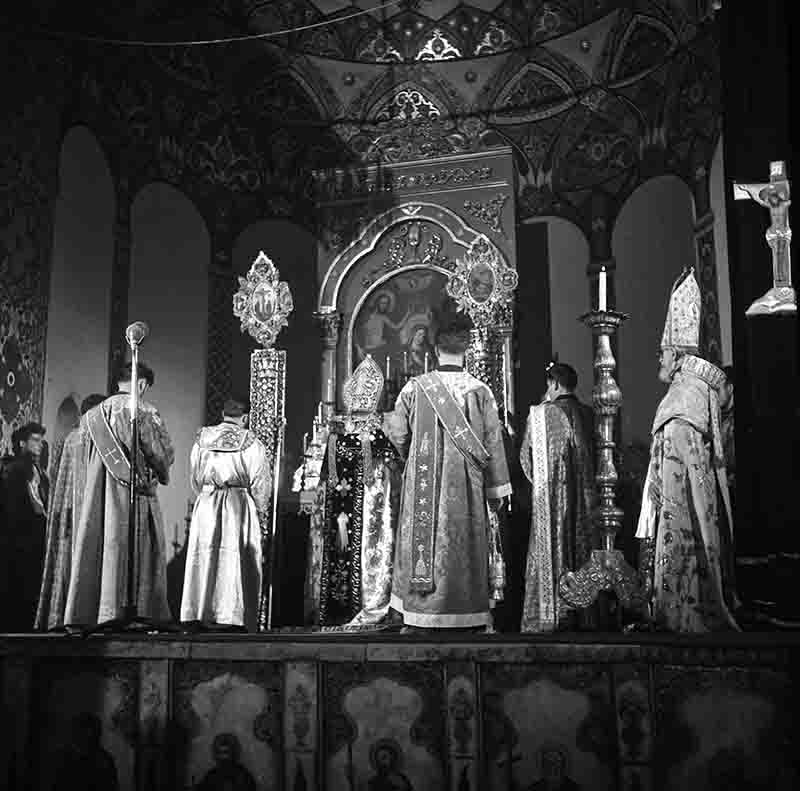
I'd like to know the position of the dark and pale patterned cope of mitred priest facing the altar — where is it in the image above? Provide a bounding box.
[310,429,400,626]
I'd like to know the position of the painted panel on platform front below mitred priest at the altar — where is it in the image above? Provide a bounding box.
[323,663,445,791]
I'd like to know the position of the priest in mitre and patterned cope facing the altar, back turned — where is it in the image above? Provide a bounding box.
[309,354,402,628]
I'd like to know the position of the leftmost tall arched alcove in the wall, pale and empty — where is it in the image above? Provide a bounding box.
[43,126,115,454]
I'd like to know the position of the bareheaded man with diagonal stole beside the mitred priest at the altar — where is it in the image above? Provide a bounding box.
[386,306,511,628]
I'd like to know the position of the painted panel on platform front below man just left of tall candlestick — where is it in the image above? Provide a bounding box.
[483,665,617,791]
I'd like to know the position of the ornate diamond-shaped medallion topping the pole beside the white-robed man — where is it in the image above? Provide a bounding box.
[233,251,294,349]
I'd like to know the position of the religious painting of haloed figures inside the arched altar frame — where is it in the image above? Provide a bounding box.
[353,269,448,378]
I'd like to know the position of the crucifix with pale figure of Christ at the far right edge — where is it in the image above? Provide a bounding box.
[733,162,797,316]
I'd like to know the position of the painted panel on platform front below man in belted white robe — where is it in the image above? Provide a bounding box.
[173,662,282,791]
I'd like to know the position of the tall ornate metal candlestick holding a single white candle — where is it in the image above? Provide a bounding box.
[559,268,646,610]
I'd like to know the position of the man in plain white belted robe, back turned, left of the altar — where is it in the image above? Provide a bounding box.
[181,399,272,632]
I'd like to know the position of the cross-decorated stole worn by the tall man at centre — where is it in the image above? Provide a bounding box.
[410,371,489,593]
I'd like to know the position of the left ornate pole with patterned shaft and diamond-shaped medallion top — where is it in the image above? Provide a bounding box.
[233,252,294,631]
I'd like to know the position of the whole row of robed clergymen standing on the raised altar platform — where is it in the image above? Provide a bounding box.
[0,270,738,632]
